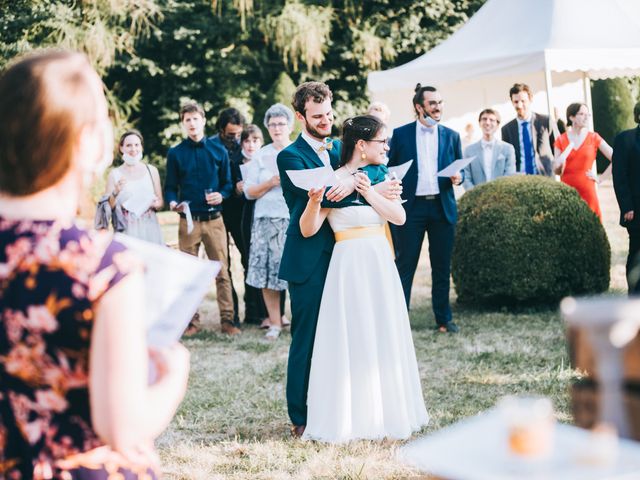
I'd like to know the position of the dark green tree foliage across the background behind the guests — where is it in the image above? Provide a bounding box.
[0,0,485,171]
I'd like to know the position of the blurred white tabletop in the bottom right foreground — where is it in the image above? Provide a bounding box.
[399,409,640,480]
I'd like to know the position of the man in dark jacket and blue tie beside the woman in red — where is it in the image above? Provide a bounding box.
[502,83,553,177]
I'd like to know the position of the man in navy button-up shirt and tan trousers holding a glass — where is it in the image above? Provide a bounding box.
[165,102,240,335]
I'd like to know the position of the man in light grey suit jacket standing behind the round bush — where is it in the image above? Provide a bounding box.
[462,108,516,190]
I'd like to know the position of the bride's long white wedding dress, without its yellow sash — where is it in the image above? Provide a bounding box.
[303,206,429,443]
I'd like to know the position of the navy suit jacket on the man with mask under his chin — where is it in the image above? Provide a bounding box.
[388,121,462,224]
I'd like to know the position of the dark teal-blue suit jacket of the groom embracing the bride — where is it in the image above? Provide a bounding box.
[277,135,342,283]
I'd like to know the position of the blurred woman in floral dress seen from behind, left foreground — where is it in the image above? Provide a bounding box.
[0,51,189,480]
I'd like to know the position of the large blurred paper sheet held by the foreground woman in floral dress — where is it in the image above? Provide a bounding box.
[115,233,221,348]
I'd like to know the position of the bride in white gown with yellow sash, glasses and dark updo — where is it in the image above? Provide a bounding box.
[300,115,429,443]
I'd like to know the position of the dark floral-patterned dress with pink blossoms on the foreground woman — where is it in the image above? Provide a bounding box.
[0,218,153,480]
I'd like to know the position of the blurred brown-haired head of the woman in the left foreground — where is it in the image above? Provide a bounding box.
[0,51,97,196]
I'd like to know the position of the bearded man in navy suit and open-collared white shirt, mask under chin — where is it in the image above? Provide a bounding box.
[389,84,463,333]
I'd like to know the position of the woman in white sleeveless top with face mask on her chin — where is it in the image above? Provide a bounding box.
[105,130,164,245]
